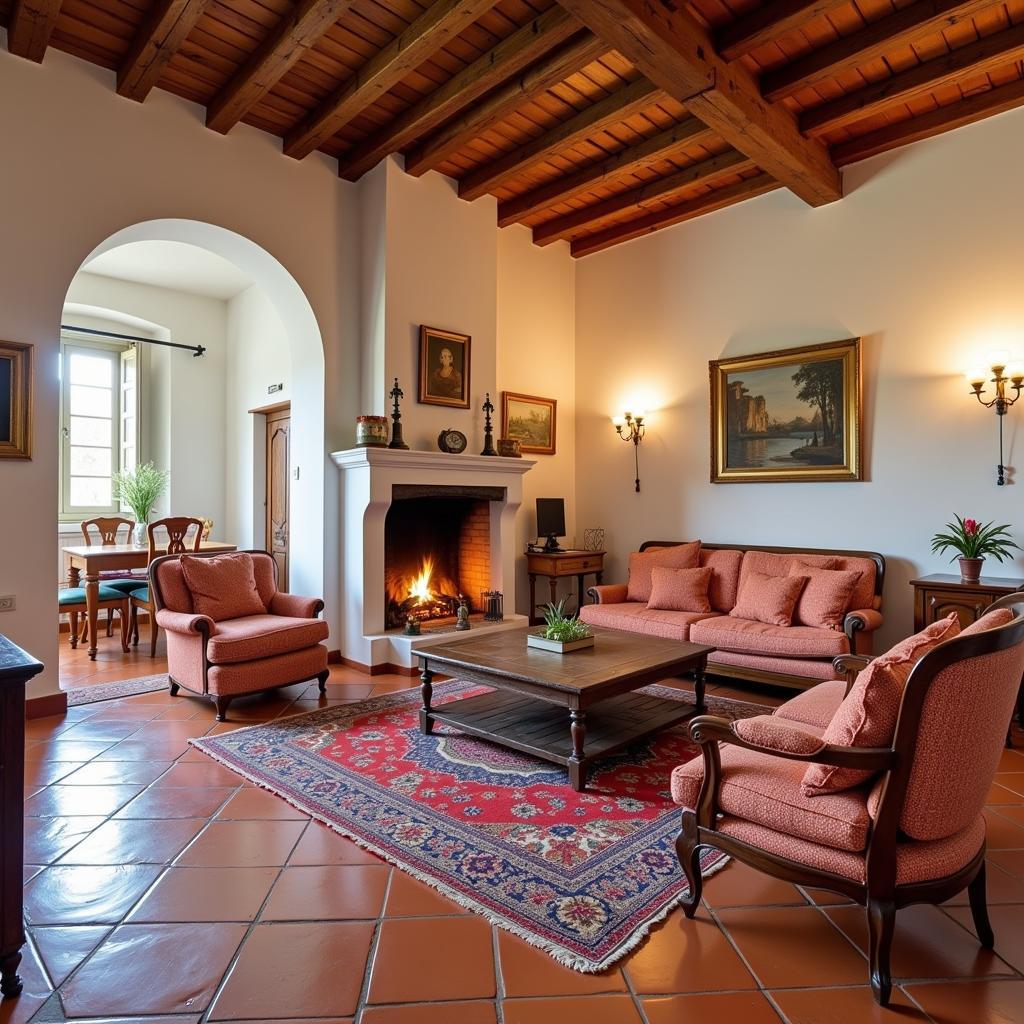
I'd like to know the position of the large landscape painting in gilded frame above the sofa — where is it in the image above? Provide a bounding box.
[709,338,863,483]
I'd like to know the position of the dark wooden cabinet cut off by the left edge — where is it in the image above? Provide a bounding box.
[0,636,43,997]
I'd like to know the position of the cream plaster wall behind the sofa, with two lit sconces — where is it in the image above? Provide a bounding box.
[577,111,1024,643]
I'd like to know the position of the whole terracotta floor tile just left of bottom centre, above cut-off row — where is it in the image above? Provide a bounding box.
[367,915,496,1004]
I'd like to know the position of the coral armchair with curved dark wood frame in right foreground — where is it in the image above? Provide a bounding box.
[673,593,1024,1006]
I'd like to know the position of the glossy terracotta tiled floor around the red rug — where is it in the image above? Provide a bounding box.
[8,653,1024,1024]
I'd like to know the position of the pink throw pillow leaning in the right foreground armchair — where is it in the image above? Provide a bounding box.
[803,611,961,797]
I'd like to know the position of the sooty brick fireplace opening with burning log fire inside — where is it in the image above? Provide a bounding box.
[384,485,505,629]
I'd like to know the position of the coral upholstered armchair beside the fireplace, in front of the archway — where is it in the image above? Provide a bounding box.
[150,551,328,722]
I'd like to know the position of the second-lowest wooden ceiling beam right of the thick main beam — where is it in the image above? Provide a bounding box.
[800,25,1024,133]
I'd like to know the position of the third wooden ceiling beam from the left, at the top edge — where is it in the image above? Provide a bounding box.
[206,0,355,134]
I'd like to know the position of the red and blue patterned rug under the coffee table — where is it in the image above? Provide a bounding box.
[191,681,765,972]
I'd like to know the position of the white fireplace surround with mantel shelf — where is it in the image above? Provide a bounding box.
[331,447,535,670]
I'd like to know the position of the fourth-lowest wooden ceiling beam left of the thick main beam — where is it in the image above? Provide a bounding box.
[459,78,662,200]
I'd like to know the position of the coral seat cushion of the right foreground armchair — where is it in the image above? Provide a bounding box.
[672,741,870,853]
